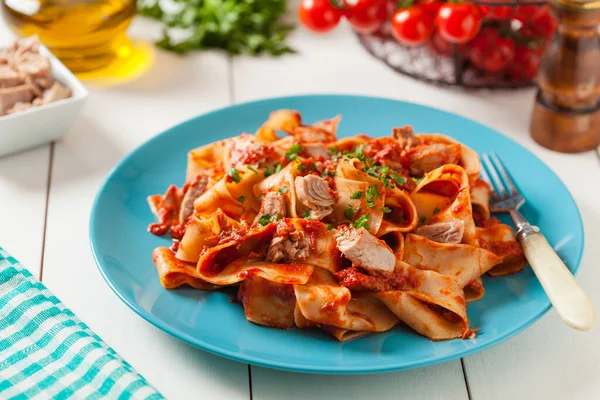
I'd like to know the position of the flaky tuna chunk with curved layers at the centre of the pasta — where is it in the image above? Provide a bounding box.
[294,175,335,220]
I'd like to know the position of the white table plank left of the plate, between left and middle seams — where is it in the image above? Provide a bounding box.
[39,19,248,399]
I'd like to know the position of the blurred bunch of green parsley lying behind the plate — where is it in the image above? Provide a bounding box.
[138,0,294,56]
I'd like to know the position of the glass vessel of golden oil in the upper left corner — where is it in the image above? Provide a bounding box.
[0,0,136,72]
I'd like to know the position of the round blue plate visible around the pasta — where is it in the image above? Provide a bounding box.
[90,95,583,374]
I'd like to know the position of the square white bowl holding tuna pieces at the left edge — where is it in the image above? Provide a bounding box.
[0,46,88,156]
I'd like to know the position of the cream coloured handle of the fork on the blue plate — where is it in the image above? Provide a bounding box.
[521,233,596,331]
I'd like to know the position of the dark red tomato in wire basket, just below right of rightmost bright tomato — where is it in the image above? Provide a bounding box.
[468,28,515,72]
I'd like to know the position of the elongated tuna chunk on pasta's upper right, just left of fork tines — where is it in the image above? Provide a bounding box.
[408,143,461,176]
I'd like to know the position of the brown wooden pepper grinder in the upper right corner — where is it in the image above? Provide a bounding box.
[530,0,600,153]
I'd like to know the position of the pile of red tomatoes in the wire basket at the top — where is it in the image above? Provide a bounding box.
[298,0,556,81]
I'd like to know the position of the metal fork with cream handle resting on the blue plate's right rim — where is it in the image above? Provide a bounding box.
[481,153,596,331]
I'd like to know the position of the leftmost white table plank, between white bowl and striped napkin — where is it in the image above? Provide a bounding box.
[0,24,50,276]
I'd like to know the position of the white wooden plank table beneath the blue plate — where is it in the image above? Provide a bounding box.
[0,14,600,400]
